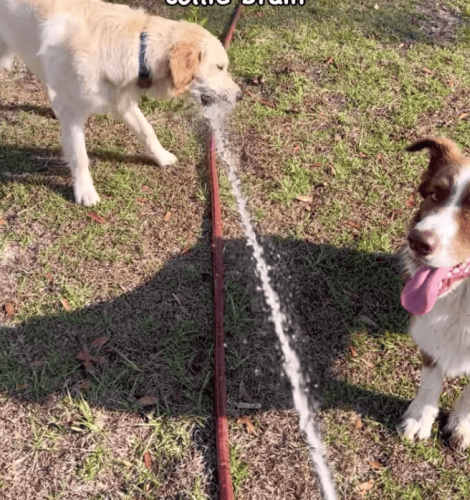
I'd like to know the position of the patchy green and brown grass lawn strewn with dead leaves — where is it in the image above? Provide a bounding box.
[0,0,470,500]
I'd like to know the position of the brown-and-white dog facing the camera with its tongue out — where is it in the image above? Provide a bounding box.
[401,137,470,447]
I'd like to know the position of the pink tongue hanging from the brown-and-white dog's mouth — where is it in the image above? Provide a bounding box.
[401,266,452,315]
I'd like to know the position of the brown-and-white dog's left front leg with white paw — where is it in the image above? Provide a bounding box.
[400,364,444,440]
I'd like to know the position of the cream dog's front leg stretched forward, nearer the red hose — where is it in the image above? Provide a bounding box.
[117,106,178,167]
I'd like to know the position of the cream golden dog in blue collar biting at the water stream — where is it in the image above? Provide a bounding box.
[0,0,241,205]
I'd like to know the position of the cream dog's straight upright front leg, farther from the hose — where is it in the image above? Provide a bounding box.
[58,114,100,207]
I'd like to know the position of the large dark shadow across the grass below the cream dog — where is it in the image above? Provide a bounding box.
[0,234,406,420]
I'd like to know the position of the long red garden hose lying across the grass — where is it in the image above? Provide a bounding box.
[209,3,243,500]
